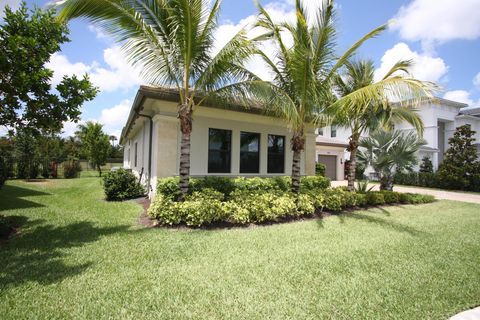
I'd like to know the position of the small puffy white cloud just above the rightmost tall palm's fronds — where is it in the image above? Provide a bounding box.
[375,42,448,82]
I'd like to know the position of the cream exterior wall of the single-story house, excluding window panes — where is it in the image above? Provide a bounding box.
[124,100,316,196]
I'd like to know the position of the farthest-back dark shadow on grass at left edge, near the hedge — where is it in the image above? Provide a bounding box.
[0,185,51,211]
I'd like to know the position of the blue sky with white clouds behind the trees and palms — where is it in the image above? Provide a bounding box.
[0,0,480,137]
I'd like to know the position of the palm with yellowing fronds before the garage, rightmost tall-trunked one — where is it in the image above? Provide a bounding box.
[331,60,434,191]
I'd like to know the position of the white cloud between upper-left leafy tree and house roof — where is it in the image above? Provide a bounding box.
[46,46,141,92]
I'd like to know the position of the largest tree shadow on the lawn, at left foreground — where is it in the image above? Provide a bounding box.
[0,217,141,292]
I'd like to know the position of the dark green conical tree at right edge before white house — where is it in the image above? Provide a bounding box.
[437,124,480,190]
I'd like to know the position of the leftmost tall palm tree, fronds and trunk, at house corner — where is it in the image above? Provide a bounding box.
[59,0,256,200]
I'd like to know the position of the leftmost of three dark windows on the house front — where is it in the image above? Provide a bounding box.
[208,129,232,173]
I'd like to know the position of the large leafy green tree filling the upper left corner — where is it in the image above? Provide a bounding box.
[0,2,97,134]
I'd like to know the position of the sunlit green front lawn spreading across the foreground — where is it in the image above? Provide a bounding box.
[0,177,480,319]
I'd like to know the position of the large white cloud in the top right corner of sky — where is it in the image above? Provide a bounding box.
[392,0,480,48]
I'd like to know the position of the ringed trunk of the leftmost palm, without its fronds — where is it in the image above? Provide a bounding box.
[178,104,192,201]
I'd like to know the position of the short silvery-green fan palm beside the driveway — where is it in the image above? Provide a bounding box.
[358,130,427,190]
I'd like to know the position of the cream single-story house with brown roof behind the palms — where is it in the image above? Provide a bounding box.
[120,86,315,196]
